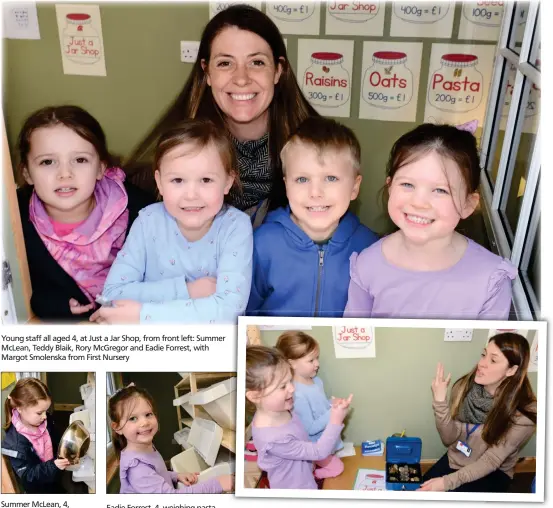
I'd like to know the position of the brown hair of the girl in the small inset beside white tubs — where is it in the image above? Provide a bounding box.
[108,385,157,458]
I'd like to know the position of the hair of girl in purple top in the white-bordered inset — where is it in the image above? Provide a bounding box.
[246,346,290,411]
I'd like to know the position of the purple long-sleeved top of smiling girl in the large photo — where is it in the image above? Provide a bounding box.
[344,238,517,320]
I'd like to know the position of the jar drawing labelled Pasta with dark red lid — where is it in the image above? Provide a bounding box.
[428,53,484,113]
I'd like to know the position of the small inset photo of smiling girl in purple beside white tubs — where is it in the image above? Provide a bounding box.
[106,372,236,494]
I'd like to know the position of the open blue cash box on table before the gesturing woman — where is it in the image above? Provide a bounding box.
[386,436,422,490]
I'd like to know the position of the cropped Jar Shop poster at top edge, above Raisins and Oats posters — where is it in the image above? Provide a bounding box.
[325,0,385,37]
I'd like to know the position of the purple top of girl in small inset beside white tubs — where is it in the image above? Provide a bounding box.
[119,450,223,494]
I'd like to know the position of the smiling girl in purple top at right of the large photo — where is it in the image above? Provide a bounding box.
[344,124,517,320]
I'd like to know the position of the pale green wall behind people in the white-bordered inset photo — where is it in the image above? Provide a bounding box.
[261,326,537,459]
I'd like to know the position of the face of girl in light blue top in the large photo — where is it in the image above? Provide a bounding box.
[155,143,234,242]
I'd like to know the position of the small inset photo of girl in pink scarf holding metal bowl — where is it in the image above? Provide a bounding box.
[2,372,96,494]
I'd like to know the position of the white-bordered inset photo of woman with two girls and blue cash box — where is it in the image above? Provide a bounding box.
[236,317,546,501]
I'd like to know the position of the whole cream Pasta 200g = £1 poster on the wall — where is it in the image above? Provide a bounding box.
[424,44,495,127]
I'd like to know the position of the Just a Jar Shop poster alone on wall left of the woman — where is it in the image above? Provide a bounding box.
[56,4,106,76]
